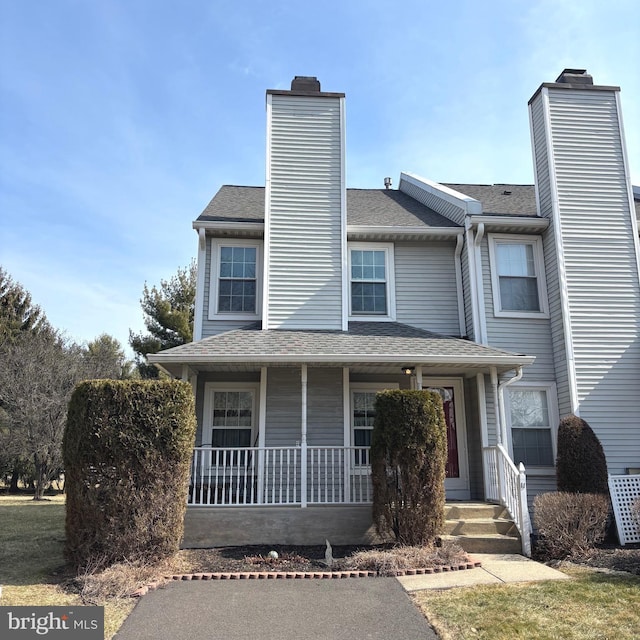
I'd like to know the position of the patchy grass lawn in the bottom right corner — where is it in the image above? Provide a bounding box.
[414,568,640,640]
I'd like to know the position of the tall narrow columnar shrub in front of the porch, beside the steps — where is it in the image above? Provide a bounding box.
[371,390,447,545]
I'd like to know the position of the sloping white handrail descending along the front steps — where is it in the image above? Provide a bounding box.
[483,444,532,557]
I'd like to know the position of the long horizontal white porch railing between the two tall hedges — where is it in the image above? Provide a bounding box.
[187,446,373,506]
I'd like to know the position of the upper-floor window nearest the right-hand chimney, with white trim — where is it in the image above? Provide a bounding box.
[489,234,548,317]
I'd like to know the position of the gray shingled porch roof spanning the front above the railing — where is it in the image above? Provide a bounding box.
[148,322,535,375]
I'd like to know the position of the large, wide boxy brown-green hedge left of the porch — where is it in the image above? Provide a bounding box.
[63,380,196,570]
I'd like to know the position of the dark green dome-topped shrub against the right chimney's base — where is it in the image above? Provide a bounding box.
[556,415,609,496]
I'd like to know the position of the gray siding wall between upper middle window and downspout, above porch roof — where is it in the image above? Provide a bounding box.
[394,242,460,335]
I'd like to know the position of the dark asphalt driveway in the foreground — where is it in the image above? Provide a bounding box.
[115,578,437,640]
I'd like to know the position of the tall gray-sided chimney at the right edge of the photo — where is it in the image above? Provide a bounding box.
[529,69,640,474]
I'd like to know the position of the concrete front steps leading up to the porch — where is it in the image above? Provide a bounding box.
[442,502,522,553]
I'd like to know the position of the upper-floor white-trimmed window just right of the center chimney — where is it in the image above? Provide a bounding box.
[349,243,395,320]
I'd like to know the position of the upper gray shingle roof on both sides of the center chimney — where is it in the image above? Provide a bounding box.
[198,185,457,227]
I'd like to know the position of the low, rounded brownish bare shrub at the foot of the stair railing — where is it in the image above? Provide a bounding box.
[533,492,609,560]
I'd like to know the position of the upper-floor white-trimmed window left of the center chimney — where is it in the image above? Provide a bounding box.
[209,238,261,320]
